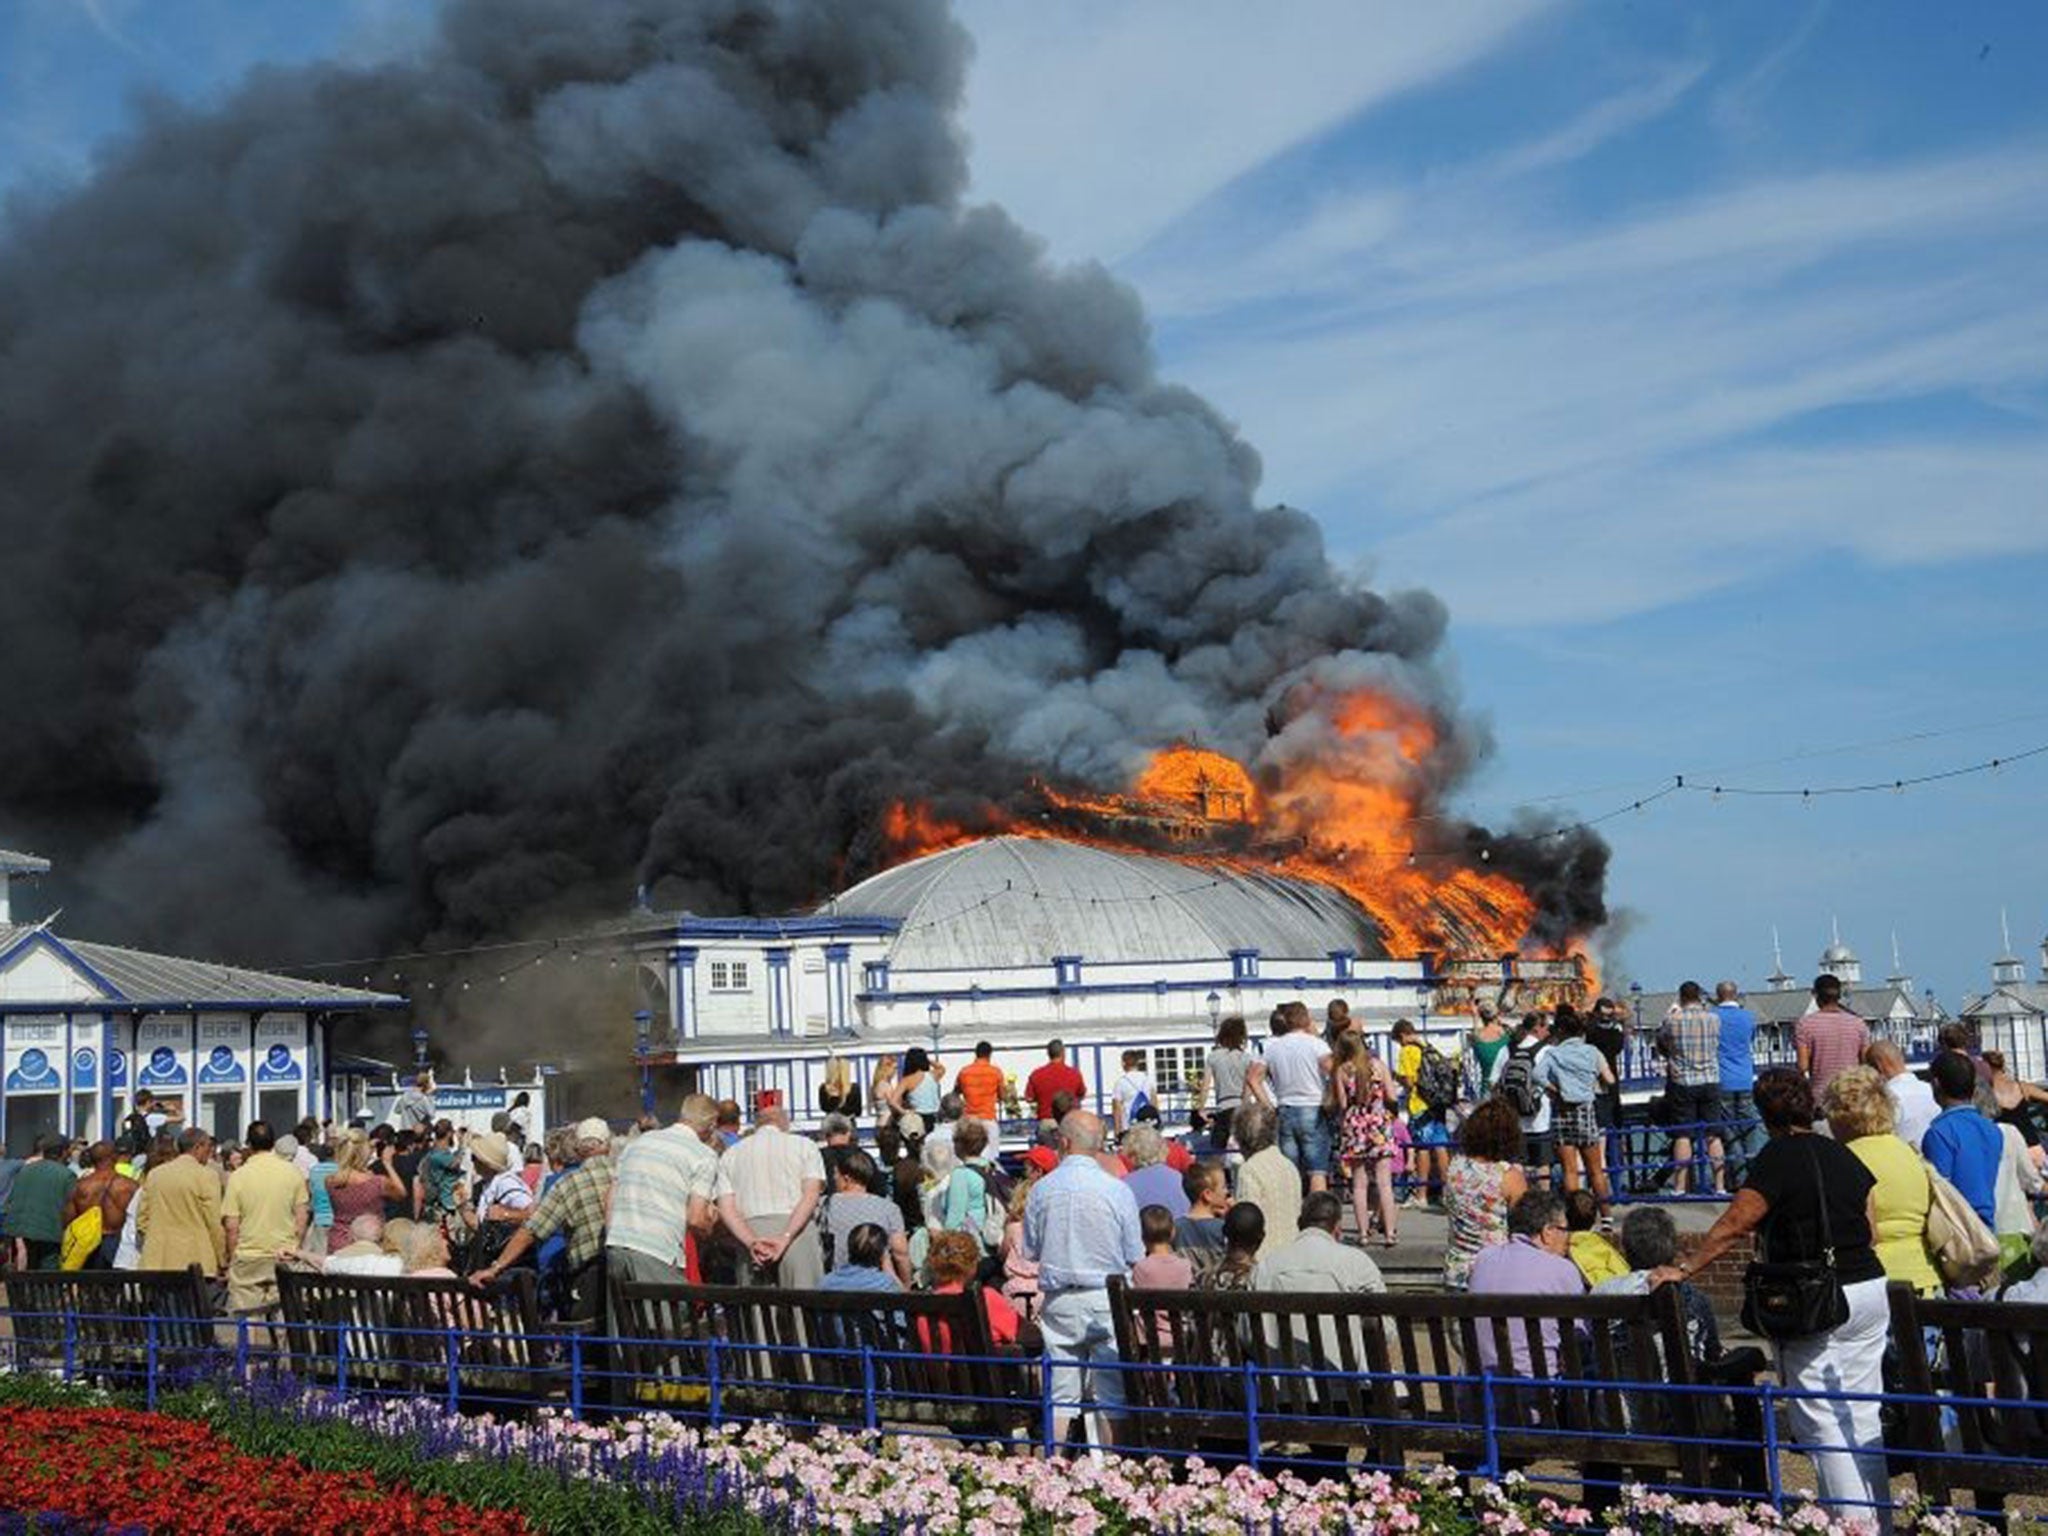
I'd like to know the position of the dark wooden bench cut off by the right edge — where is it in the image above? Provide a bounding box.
[1888,1284,2048,1509]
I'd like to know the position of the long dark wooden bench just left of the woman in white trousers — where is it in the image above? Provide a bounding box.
[1110,1278,1714,1487]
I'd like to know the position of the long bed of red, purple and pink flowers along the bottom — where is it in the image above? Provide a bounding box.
[0,1378,1949,1536]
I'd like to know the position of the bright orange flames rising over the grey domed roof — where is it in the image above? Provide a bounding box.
[883,690,1597,983]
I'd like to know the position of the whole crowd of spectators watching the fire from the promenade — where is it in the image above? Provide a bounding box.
[0,977,2048,1531]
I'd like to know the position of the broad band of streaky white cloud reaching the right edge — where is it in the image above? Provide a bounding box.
[1141,128,2048,625]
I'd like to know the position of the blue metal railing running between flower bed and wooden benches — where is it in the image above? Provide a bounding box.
[0,1307,2048,1531]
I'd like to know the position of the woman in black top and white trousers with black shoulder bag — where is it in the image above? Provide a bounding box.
[1651,1067,1892,1532]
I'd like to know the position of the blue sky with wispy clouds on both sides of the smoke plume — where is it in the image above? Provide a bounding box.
[0,0,2048,1006]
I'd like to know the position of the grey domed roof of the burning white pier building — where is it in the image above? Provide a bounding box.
[821,838,1386,971]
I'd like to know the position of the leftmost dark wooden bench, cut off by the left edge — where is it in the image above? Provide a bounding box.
[0,1264,219,1386]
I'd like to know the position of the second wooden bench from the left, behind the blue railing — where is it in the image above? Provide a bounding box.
[276,1270,588,1405]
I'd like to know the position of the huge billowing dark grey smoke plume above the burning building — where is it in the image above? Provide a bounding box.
[0,0,1599,978]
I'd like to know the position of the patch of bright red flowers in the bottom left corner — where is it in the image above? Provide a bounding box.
[0,1405,532,1536]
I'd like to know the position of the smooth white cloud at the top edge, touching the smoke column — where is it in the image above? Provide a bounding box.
[958,0,1548,260]
